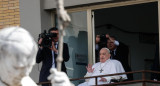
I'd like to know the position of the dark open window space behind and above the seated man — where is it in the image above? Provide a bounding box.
[93,2,159,78]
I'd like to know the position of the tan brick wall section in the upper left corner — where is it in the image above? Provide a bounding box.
[0,0,20,29]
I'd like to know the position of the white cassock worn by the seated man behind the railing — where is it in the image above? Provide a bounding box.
[78,59,127,86]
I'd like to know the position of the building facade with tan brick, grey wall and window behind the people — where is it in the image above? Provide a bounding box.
[0,0,160,84]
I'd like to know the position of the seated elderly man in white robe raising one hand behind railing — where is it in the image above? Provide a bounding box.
[78,48,127,86]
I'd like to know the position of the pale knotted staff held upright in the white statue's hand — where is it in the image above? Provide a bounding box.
[55,0,71,71]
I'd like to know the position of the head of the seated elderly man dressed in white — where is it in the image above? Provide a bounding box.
[99,48,110,63]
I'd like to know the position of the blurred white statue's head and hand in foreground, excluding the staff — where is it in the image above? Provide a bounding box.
[0,27,71,86]
